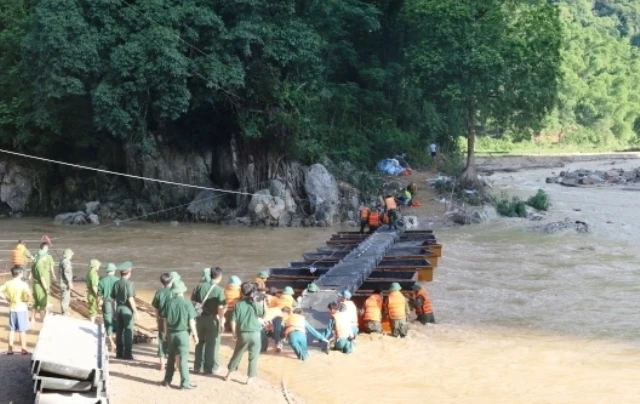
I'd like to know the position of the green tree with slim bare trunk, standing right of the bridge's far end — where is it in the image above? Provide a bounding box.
[405,0,561,182]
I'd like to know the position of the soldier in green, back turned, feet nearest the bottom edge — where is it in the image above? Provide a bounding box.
[162,281,199,390]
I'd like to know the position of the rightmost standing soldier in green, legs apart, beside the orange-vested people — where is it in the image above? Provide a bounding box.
[224,282,267,384]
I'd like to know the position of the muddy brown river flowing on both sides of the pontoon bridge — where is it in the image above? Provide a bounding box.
[0,162,640,403]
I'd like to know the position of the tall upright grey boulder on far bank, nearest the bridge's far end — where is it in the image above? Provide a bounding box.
[304,164,339,225]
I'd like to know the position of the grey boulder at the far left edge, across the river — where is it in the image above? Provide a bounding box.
[0,161,33,213]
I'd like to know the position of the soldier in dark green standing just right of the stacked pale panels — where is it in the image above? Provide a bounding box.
[111,261,138,360]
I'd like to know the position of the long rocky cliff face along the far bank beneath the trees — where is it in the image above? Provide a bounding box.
[0,139,360,226]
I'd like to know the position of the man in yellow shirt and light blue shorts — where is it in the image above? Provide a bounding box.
[0,265,31,355]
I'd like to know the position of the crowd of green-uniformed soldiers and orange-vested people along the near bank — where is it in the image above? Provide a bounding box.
[5,238,435,390]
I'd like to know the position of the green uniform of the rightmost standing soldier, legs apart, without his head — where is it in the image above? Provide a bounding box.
[229,298,265,377]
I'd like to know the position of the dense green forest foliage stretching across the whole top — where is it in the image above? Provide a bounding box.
[0,0,640,176]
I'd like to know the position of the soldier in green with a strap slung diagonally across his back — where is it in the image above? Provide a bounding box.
[191,267,227,374]
